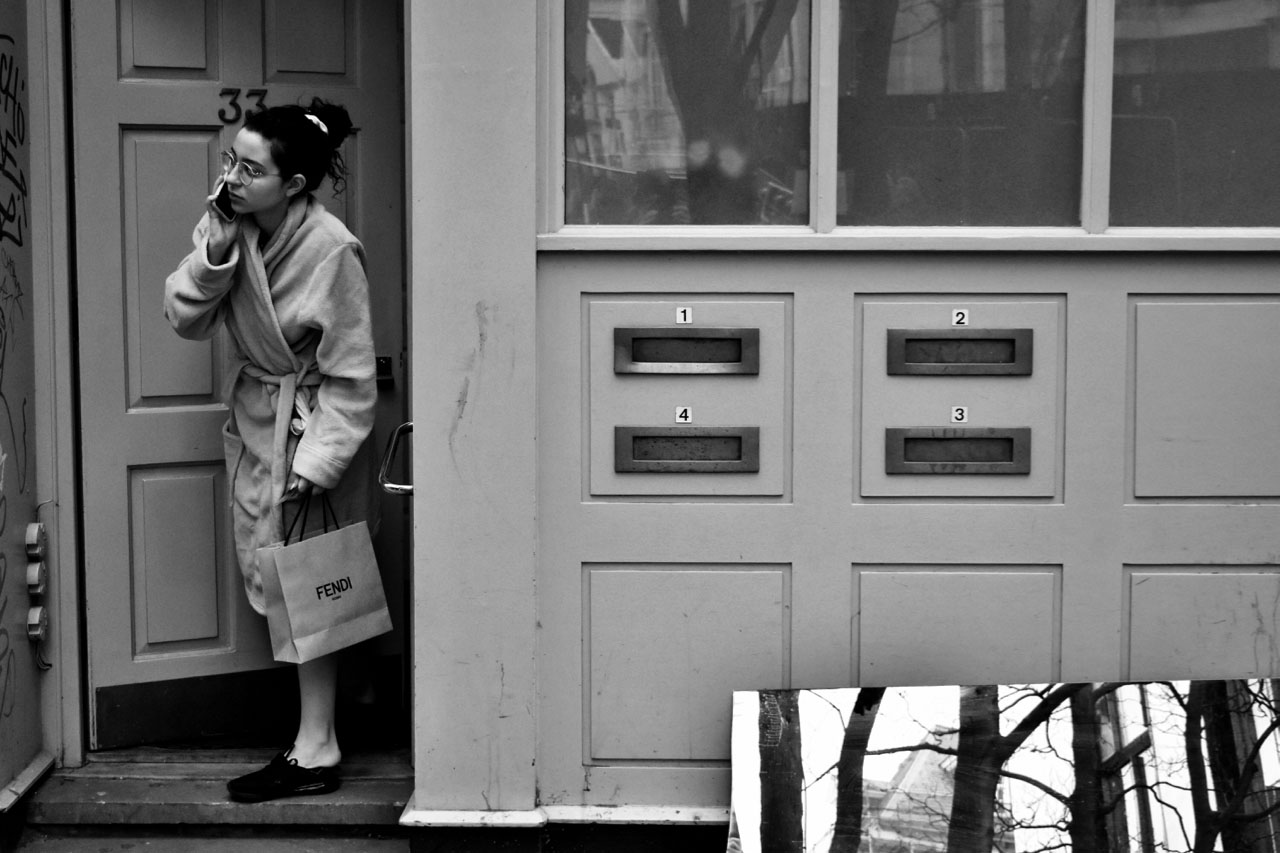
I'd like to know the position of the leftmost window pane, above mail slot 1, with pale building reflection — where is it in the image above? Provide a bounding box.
[564,0,809,225]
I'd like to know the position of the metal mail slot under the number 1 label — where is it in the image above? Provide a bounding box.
[613,325,760,375]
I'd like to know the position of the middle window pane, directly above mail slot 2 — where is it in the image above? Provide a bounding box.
[837,0,1084,225]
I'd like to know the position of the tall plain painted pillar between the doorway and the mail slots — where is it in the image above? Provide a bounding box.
[402,0,540,825]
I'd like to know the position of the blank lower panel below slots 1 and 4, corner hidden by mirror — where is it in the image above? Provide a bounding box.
[584,566,790,763]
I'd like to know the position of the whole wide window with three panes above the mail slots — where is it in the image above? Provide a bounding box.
[552,0,1280,233]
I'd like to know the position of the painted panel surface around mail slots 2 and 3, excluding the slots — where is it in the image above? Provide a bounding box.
[854,293,1065,498]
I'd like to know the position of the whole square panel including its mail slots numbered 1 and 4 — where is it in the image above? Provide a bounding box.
[584,293,791,498]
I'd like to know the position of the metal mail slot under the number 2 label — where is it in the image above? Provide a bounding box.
[887,328,1033,377]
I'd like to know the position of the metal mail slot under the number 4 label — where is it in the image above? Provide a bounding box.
[613,427,760,474]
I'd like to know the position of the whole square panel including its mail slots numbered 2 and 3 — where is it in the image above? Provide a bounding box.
[856,293,1066,498]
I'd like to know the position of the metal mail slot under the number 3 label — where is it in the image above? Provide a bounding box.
[884,427,1032,474]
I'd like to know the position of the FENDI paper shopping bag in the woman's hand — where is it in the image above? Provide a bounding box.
[250,491,392,663]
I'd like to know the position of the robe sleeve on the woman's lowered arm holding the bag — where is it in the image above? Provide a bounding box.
[293,243,378,488]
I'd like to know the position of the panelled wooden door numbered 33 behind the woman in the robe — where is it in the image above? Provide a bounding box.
[70,0,404,748]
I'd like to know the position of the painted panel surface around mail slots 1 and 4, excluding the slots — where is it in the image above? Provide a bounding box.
[584,293,790,497]
